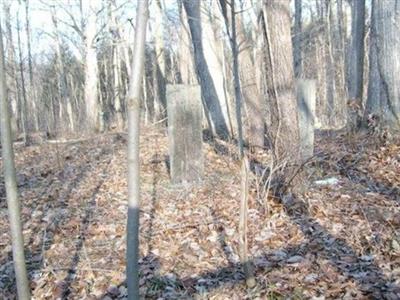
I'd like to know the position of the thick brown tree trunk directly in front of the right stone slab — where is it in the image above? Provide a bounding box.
[263,0,300,162]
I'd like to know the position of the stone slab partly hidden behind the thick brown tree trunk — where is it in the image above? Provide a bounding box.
[297,79,316,160]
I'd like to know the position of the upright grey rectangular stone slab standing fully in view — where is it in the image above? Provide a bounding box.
[166,84,204,184]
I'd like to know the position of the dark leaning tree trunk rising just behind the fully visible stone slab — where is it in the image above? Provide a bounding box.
[183,0,229,139]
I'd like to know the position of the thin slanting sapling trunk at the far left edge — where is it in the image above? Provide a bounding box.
[0,16,30,300]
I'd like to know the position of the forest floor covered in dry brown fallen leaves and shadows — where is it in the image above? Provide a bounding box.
[0,127,400,299]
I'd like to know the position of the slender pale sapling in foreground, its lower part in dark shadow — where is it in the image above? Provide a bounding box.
[126,0,148,300]
